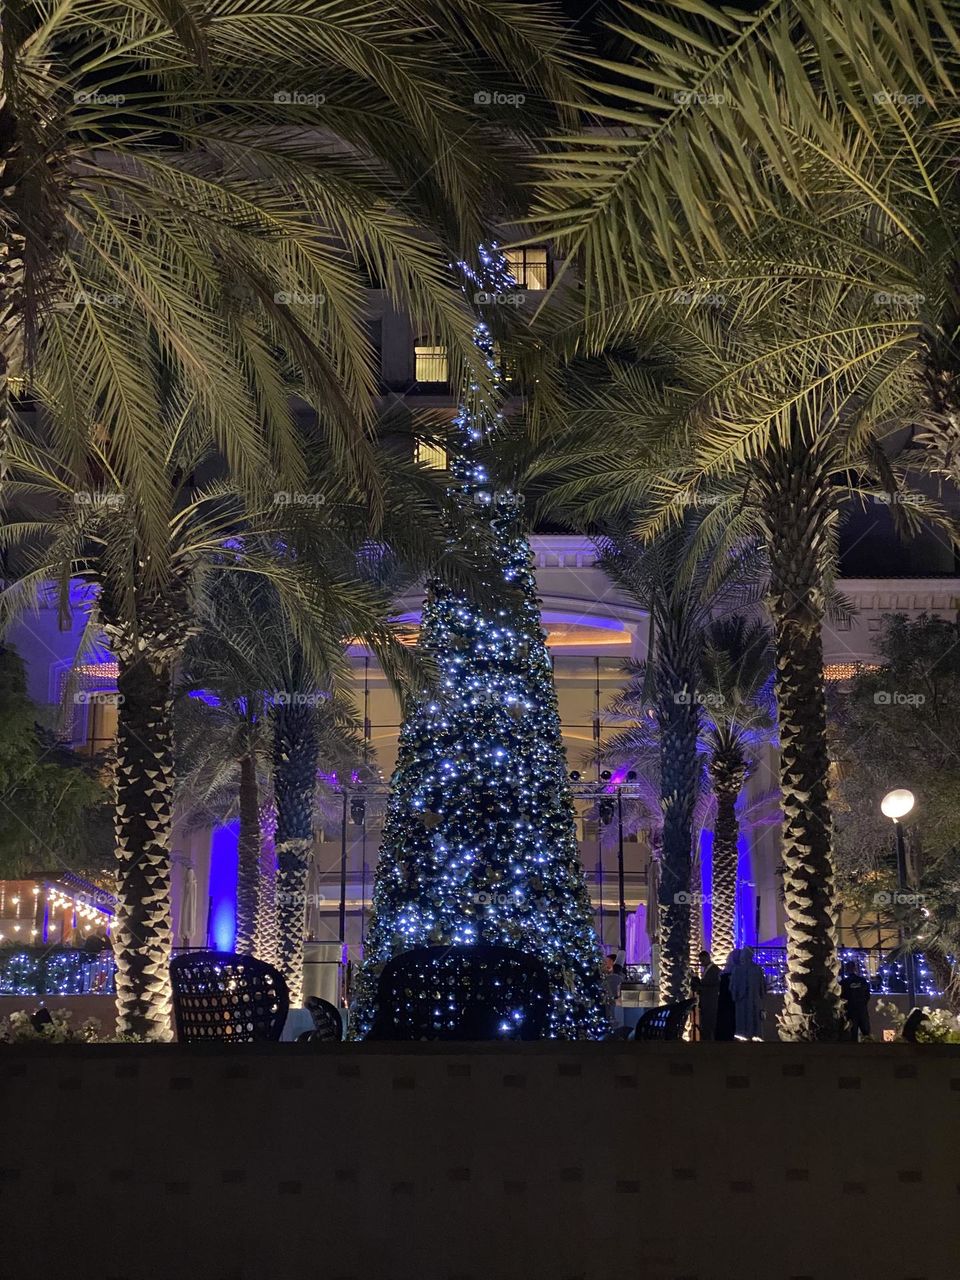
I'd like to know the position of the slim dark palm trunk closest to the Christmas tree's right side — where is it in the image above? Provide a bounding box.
[657,622,700,1004]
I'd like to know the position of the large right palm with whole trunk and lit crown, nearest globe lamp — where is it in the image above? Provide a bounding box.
[535,293,955,1038]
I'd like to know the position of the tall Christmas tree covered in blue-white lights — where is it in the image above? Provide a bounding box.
[352,250,608,1039]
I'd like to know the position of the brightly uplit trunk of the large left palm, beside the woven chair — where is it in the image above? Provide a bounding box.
[113,652,173,1041]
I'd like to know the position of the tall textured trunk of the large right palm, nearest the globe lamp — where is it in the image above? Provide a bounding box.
[756,436,845,1041]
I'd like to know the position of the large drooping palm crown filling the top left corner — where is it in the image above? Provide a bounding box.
[0,0,578,529]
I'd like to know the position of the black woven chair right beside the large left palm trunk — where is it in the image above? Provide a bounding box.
[170,951,291,1044]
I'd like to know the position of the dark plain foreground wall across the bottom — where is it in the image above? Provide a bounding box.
[0,1042,960,1280]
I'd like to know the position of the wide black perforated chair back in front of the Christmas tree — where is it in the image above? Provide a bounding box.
[366,943,550,1041]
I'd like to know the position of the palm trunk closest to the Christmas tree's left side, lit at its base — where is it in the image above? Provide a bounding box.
[274,703,317,1006]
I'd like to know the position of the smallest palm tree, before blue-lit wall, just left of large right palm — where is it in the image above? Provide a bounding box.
[701,616,776,956]
